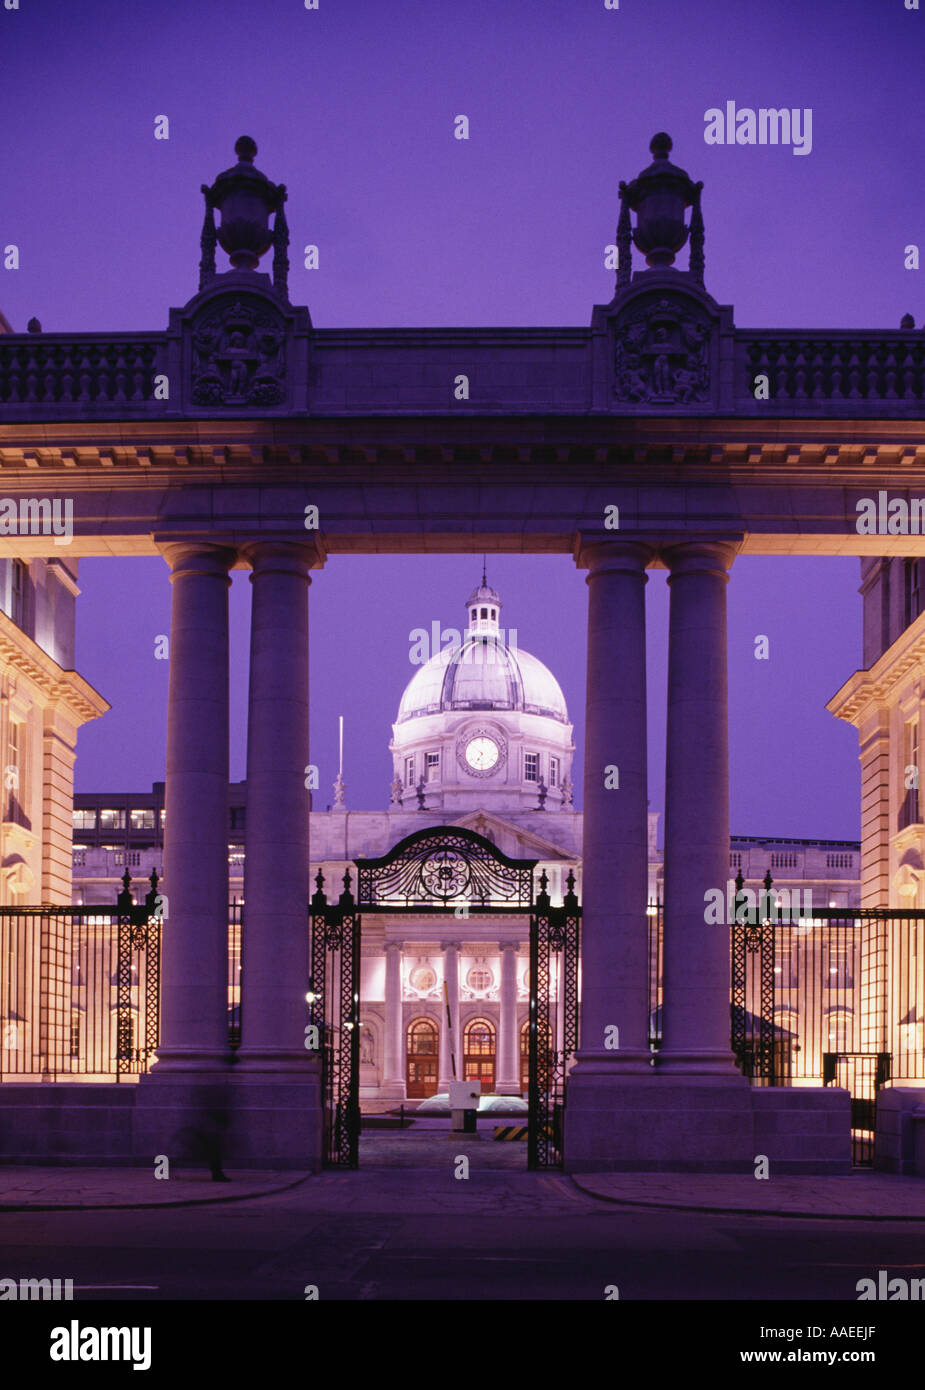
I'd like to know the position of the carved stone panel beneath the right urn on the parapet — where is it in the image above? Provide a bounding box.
[613,299,709,406]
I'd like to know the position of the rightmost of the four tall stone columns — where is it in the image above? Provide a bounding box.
[658,542,737,1076]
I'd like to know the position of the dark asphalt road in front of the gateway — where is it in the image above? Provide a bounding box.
[0,1162,925,1314]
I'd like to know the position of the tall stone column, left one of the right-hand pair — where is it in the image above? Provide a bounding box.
[572,541,654,1079]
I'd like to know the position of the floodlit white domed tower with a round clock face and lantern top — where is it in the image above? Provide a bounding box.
[389,574,574,816]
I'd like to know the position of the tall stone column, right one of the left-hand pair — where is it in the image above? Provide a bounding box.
[235,541,317,1072]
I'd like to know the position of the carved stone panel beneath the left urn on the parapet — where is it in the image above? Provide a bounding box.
[192,300,285,406]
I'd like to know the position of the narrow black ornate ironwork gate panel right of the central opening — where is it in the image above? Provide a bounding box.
[527,870,581,1169]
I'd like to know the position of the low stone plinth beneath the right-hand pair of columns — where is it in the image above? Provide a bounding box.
[563,1072,851,1176]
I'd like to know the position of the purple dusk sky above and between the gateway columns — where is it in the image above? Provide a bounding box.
[0,0,925,838]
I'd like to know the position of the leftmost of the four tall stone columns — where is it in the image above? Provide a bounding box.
[153,542,235,1077]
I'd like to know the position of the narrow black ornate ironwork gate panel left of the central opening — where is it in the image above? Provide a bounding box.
[309,869,360,1168]
